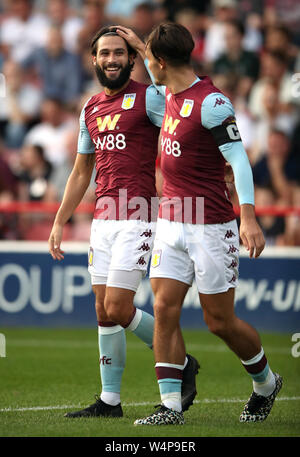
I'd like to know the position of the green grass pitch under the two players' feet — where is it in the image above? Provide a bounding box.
[0,328,300,437]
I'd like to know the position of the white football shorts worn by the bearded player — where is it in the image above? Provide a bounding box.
[88,219,156,291]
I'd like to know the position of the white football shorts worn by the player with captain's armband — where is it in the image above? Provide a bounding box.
[150,218,239,294]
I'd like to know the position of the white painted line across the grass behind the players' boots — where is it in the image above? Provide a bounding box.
[0,397,300,413]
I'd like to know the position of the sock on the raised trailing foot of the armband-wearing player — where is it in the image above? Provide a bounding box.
[241,348,276,397]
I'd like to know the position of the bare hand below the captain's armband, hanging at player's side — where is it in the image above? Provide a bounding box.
[240,214,265,258]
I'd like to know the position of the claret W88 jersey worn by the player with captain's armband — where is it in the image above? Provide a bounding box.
[159,77,235,224]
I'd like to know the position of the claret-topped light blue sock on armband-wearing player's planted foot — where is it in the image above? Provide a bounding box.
[155,363,183,412]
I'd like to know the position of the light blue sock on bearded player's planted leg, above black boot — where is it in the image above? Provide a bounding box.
[98,322,126,406]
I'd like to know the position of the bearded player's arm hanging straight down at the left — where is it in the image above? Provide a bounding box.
[48,103,95,260]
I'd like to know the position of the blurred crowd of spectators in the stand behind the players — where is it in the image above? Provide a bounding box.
[0,0,300,246]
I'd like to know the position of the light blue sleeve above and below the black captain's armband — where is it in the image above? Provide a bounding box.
[201,93,254,205]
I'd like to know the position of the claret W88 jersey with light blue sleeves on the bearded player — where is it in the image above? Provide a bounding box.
[78,80,165,220]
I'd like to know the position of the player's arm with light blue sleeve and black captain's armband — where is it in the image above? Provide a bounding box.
[201,93,265,257]
